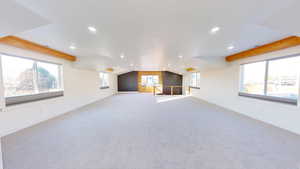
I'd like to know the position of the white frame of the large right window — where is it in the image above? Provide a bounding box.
[238,54,300,105]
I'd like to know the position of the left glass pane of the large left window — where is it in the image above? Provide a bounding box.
[2,55,36,97]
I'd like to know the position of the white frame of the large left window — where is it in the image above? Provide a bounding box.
[0,52,64,105]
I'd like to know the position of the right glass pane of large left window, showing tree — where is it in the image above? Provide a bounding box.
[37,62,61,92]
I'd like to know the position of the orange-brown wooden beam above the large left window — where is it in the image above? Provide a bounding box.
[0,36,76,62]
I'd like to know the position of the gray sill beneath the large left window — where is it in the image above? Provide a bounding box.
[5,91,64,106]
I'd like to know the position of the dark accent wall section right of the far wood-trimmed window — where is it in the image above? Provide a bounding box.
[162,71,182,95]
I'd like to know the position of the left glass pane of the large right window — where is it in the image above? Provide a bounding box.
[241,61,266,95]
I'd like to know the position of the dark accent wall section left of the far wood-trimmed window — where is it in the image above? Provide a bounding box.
[118,71,138,92]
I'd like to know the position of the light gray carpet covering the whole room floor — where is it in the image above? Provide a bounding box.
[2,94,300,169]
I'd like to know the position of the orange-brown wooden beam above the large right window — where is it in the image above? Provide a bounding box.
[226,36,300,62]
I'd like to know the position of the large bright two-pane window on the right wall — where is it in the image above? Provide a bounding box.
[240,56,300,104]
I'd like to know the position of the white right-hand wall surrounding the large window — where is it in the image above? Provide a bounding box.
[185,47,300,134]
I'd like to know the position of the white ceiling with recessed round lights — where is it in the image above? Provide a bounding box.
[0,0,300,72]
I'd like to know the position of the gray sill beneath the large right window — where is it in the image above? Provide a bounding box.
[239,92,297,105]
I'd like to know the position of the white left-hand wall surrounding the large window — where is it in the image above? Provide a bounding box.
[0,45,117,137]
